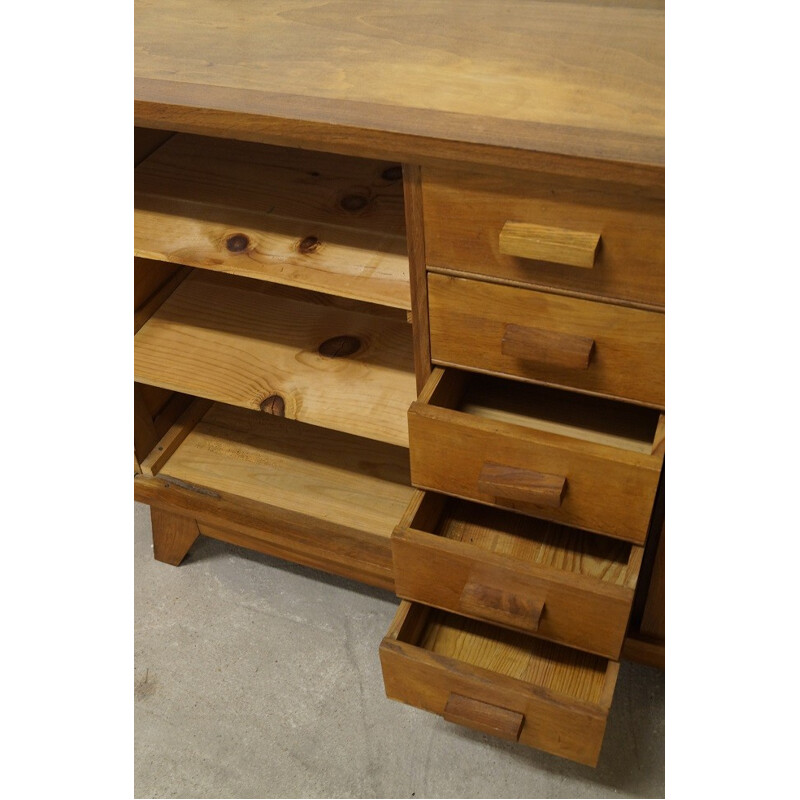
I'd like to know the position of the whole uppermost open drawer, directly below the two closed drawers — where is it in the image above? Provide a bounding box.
[408,367,664,544]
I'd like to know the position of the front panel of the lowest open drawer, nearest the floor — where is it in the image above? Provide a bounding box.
[380,602,619,766]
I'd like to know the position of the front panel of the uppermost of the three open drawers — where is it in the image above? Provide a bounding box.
[408,369,663,544]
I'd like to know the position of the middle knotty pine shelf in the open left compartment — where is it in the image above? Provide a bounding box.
[134,271,416,446]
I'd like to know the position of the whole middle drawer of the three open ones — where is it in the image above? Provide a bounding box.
[392,492,643,659]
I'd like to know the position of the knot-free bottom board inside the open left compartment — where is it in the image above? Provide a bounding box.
[159,404,412,539]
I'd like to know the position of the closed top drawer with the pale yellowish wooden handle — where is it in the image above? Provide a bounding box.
[422,162,664,308]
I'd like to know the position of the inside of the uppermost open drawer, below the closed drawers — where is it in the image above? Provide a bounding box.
[430,369,664,455]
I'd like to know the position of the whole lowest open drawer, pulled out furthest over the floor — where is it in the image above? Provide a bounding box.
[380,601,619,766]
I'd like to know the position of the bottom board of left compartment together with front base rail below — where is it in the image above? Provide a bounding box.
[134,401,413,589]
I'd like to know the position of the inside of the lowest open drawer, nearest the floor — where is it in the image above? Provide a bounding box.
[397,605,609,705]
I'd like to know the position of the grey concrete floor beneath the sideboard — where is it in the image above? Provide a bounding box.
[134,504,664,798]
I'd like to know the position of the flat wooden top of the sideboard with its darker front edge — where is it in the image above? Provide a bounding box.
[135,0,664,173]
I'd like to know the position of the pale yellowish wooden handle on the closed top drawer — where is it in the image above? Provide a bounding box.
[500,222,600,269]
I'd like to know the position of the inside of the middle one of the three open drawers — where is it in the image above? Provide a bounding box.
[404,492,642,590]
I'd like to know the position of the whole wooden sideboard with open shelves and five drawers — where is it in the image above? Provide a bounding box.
[134,0,665,764]
